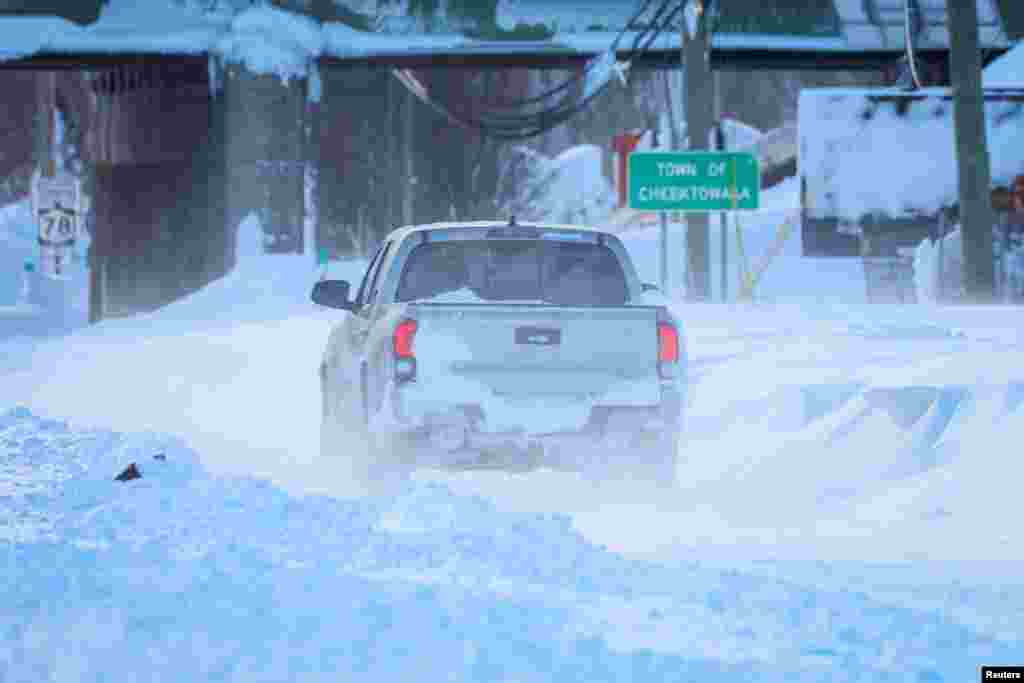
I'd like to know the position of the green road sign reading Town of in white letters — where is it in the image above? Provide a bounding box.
[628,152,761,211]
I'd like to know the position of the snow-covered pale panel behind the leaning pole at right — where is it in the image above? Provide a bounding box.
[799,88,1024,221]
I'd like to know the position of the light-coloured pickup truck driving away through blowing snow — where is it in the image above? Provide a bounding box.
[312,219,686,482]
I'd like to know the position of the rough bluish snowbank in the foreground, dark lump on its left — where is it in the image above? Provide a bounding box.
[0,409,1022,683]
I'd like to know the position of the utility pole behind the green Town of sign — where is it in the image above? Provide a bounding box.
[681,0,715,301]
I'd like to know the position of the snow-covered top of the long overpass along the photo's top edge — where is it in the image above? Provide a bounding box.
[0,0,1009,77]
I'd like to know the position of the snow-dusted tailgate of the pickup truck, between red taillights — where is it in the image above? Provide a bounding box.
[411,304,659,404]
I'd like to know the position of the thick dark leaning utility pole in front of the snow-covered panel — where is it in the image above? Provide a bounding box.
[946,0,995,303]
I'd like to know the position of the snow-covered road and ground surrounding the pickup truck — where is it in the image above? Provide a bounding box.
[0,214,1024,683]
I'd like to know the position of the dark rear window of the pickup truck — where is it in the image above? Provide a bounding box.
[396,240,629,306]
